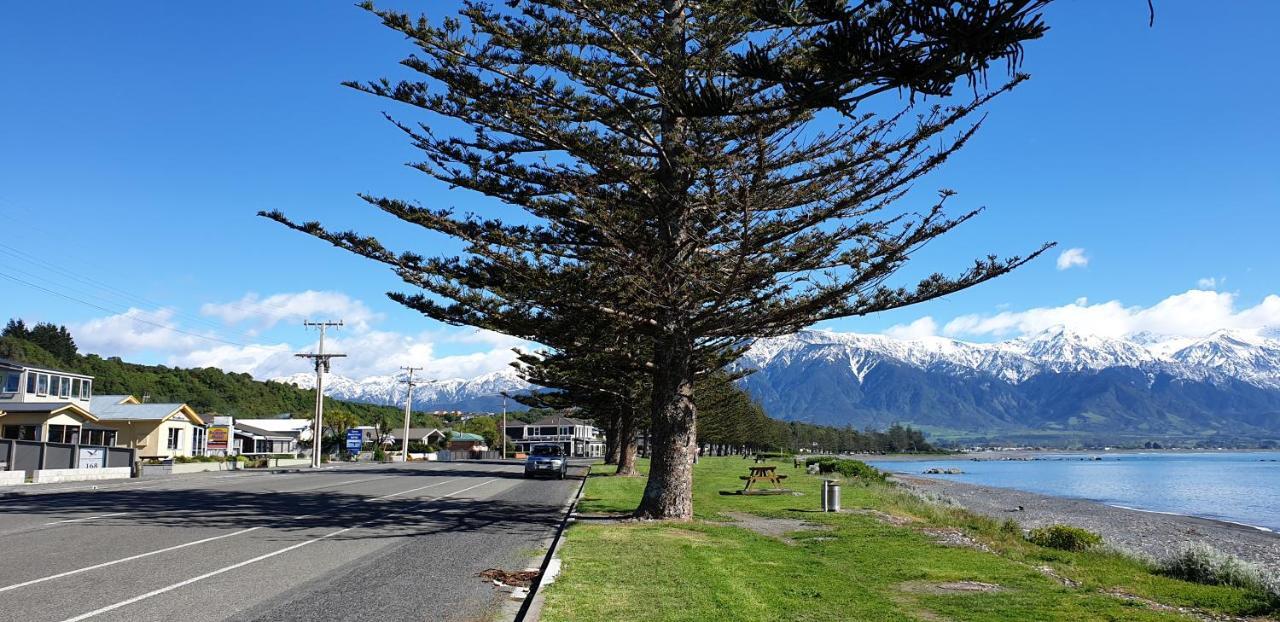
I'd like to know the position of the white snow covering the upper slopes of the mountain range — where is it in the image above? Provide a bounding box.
[274,328,1280,410]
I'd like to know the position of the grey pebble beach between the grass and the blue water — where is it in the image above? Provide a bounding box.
[890,474,1280,572]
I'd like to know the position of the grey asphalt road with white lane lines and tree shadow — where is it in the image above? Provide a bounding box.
[0,462,582,622]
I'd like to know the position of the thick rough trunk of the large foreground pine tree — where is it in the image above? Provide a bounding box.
[635,335,698,521]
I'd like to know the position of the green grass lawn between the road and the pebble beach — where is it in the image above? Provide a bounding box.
[543,457,1268,622]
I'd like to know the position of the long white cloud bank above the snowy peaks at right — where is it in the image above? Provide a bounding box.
[942,289,1280,338]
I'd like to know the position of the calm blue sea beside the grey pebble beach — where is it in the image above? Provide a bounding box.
[867,452,1280,531]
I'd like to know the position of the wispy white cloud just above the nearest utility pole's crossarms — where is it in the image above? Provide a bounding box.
[200,289,381,331]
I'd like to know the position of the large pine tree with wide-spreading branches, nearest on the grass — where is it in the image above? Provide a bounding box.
[265,0,1048,520]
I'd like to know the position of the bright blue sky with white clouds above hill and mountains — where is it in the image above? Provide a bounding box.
[0,0,1280,376]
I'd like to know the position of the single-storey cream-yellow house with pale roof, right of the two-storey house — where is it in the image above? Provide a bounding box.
[90,395,205,459]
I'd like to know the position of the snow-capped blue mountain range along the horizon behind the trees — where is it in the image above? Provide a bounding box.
[276,328,1280,440]
